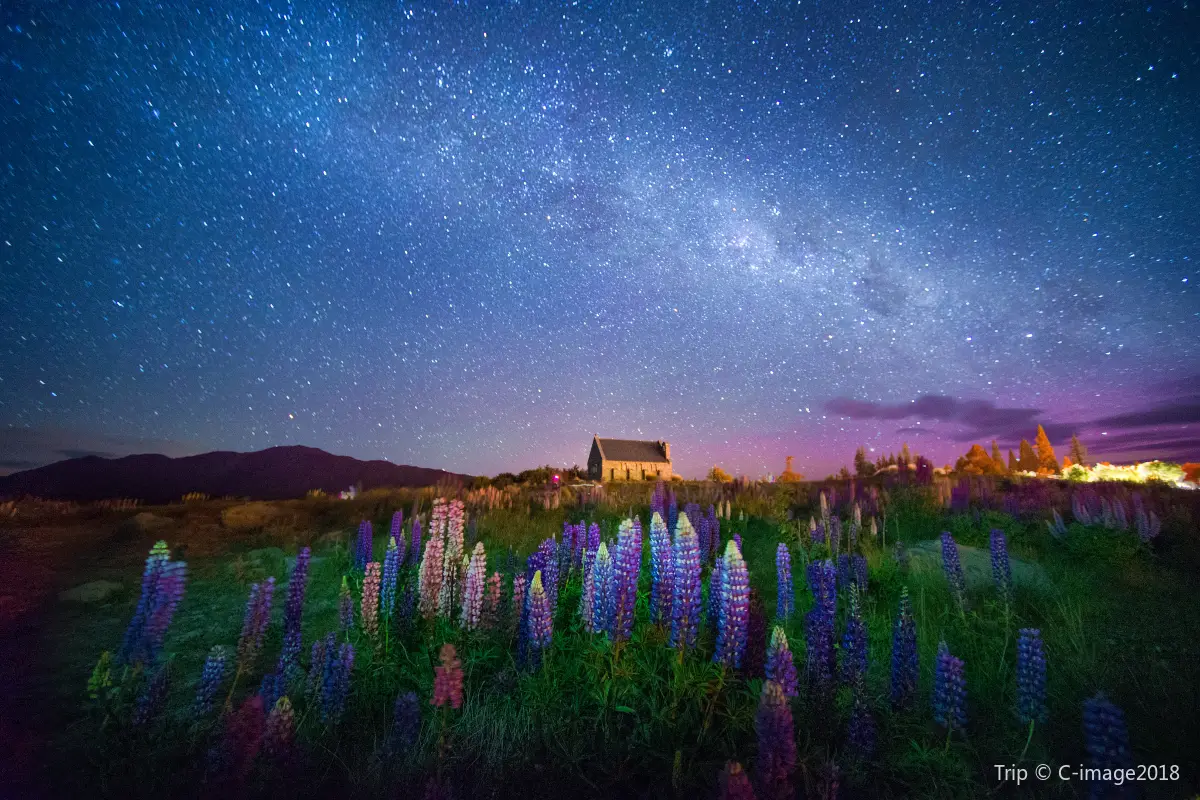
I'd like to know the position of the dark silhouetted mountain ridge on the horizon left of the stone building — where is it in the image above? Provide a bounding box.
[0,446,468,504]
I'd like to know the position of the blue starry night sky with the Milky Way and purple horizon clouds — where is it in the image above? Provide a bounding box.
[0,0,1200,476]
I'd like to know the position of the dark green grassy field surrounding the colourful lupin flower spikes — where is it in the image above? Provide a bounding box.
[0,489,1200,798]
